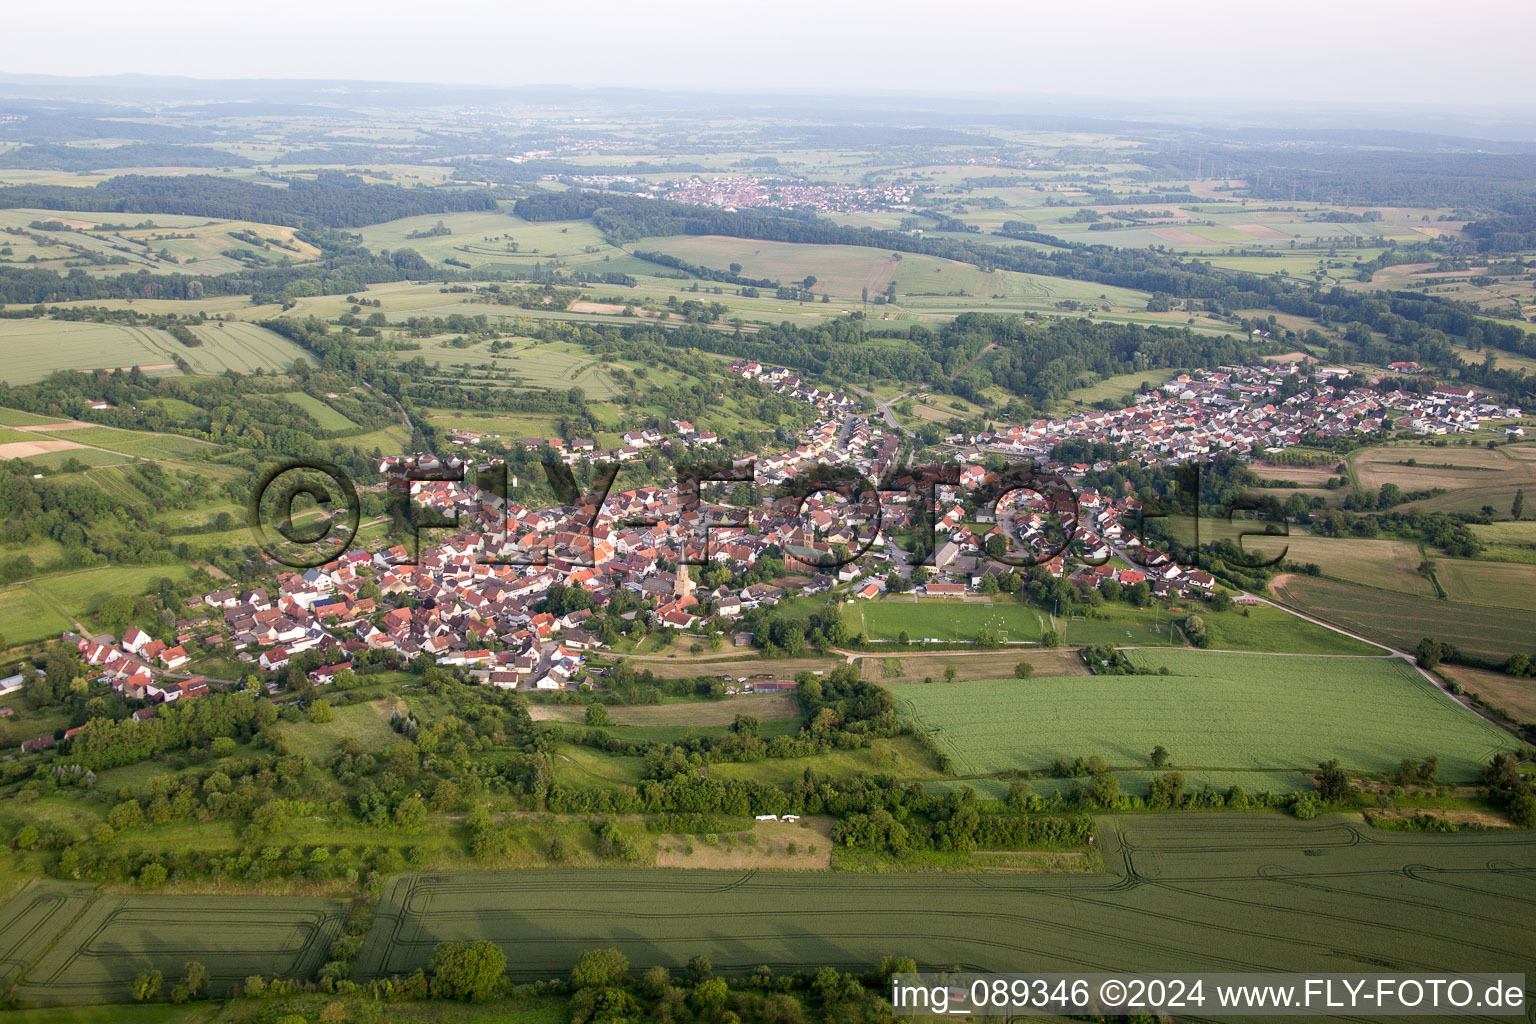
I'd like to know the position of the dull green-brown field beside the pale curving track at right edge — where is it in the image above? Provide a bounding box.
[1272,576,1531,663]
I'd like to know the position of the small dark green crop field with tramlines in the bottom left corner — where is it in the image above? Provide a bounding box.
[6,886,346,1004]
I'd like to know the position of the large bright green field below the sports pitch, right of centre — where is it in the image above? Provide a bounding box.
[897,651,1519,781]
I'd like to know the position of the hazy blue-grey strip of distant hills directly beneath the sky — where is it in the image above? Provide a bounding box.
[0,69,1536,143]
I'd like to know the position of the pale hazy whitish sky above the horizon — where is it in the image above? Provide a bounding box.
[0,0,1536,104]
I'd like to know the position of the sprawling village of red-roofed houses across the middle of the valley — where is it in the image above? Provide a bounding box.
[42,362,1519,736]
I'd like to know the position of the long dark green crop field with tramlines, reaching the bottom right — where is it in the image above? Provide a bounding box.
[356,815,1536,981]
